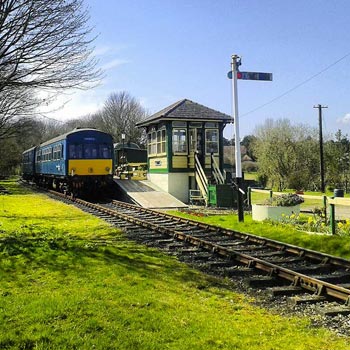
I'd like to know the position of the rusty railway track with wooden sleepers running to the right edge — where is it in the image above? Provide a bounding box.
[47,193,350,316]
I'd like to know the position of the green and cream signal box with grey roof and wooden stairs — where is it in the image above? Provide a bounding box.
[137,99,232,204]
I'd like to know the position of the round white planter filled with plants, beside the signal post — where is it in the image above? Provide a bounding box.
[252,193,304,221]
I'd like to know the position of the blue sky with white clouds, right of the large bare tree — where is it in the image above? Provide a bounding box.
[44,0,350,139]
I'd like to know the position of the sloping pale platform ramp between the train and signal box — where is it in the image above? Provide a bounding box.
[114,178,188,209]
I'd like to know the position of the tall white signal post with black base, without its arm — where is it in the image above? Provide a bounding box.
[231,55,244,222]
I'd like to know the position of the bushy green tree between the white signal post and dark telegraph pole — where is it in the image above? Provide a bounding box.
[252,119,319,190]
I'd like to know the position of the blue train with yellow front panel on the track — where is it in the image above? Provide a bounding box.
[22,129,114,195]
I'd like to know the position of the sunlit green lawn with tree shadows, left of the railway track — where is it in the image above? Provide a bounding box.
[0,182,350,350]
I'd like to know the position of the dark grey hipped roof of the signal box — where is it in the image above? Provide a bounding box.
[136,99,232,127]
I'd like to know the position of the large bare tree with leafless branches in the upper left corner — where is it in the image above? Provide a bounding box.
[0,0,100,138]
